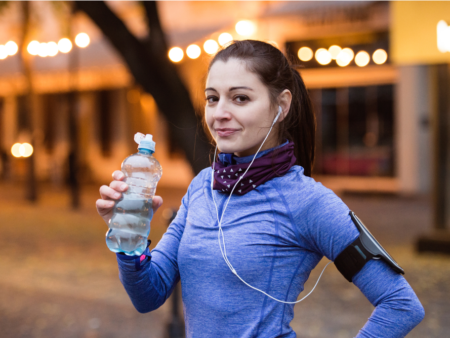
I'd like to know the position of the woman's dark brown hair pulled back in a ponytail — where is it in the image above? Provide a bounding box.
[202,40,316,176]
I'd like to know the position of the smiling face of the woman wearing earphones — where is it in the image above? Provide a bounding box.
[205,58,278,157]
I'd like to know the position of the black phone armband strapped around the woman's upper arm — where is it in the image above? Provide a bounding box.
[334,211,405,282]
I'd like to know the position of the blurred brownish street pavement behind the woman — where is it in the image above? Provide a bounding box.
[0,183,450,338]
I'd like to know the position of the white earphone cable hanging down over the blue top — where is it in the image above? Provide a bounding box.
[211,107,331,304]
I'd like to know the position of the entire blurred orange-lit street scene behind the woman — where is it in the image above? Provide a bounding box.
[0,0,450,338]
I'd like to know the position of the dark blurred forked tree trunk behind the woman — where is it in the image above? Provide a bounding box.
[74,0,210,174]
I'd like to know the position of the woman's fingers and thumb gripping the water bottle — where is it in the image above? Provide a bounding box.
[95,170,163,224]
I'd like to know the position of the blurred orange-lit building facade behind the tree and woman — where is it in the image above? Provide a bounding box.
[0,0,450,194]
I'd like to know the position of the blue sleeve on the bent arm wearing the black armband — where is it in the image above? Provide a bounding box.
[307,189,424,338]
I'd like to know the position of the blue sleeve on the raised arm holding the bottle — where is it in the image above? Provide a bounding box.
[117,184,189,313]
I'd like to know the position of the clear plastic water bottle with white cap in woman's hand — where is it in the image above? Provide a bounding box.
[106,133,162,256]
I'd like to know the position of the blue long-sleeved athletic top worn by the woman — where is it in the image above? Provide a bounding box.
[117,143,424,338]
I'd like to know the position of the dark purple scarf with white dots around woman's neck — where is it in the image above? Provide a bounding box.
[211,141,297,195]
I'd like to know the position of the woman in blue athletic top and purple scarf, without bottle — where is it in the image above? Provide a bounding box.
[97,40,424,337]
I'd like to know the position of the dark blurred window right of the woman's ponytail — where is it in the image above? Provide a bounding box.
[310,85,394,176]
